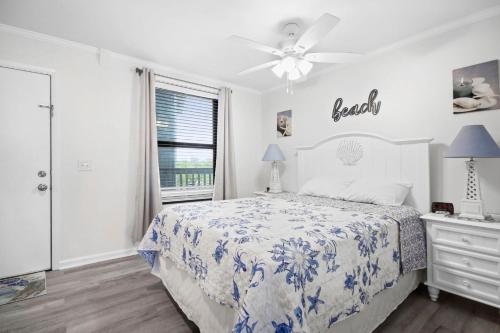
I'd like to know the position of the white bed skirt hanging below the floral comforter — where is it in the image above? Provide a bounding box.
[152,256,423,333]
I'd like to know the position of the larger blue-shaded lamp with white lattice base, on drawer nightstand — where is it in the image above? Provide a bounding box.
[444,125,500,220]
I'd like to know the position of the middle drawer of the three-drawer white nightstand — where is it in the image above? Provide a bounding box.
[432,244,500,279]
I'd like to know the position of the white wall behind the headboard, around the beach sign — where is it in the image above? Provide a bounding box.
[262,16,500,213]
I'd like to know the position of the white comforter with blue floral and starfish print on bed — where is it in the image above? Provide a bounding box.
[139,195,425,333]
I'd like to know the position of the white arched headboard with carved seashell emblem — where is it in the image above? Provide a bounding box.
[297,132,432,213]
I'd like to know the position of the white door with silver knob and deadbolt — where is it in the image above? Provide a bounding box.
[0,67,51,278]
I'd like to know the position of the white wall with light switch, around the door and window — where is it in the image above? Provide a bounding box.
[0,27,262,263]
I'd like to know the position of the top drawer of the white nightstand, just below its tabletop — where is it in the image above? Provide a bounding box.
[431,223,500,255]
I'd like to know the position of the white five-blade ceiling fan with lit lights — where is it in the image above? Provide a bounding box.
[229,13,361,82]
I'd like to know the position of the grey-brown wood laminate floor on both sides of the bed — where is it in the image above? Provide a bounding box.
[0,256,500,333]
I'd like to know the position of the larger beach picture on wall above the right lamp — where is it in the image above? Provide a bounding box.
[453,60,500,114]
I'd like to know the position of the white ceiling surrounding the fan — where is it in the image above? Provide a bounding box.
[0,0,499,91]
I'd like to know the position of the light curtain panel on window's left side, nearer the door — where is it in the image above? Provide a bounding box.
[134,68,162,240]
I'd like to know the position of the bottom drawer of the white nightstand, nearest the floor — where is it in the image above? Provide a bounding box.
[432,265,500,304]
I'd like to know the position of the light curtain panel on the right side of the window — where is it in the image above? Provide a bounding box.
[213,88,236,200]
